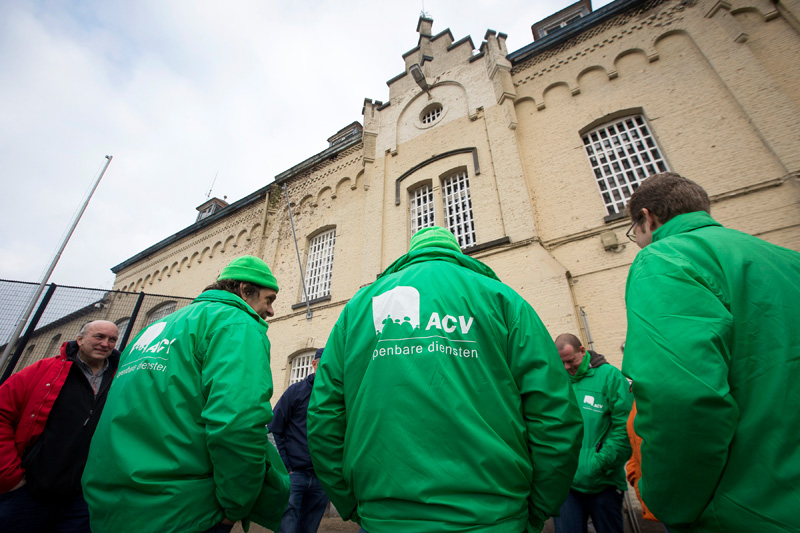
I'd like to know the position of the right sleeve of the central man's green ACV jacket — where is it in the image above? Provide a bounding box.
[507,303,583,531]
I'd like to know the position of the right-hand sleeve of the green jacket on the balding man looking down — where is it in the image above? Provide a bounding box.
[597,365,633,473]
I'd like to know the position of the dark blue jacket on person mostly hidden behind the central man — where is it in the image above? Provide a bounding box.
[269,374,316,472]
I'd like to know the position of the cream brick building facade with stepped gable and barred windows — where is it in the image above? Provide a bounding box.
[112,0,800,399]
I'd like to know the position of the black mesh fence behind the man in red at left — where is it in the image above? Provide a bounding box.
[0,280,193,383]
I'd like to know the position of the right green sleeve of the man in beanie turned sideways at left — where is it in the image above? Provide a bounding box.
[201,323,272,521]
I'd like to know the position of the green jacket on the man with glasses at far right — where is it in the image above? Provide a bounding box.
[622,212,800,533]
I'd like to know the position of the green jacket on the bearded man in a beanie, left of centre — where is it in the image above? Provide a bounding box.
[83,291,285,533]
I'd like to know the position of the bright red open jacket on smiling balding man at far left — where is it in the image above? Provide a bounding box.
[0,342,72,494]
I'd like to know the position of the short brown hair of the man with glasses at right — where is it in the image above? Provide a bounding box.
[626,172,711,224]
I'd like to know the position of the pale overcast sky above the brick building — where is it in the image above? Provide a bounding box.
[0,0,608,288]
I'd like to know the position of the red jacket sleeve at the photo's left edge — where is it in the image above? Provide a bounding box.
[0,371,27,494]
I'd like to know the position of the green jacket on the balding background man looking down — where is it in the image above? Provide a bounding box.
[570,352,633,494]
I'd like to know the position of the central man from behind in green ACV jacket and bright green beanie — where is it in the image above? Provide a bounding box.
[308,227,583,533]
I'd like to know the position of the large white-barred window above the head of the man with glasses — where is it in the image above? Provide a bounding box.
[583,115,669,215]
